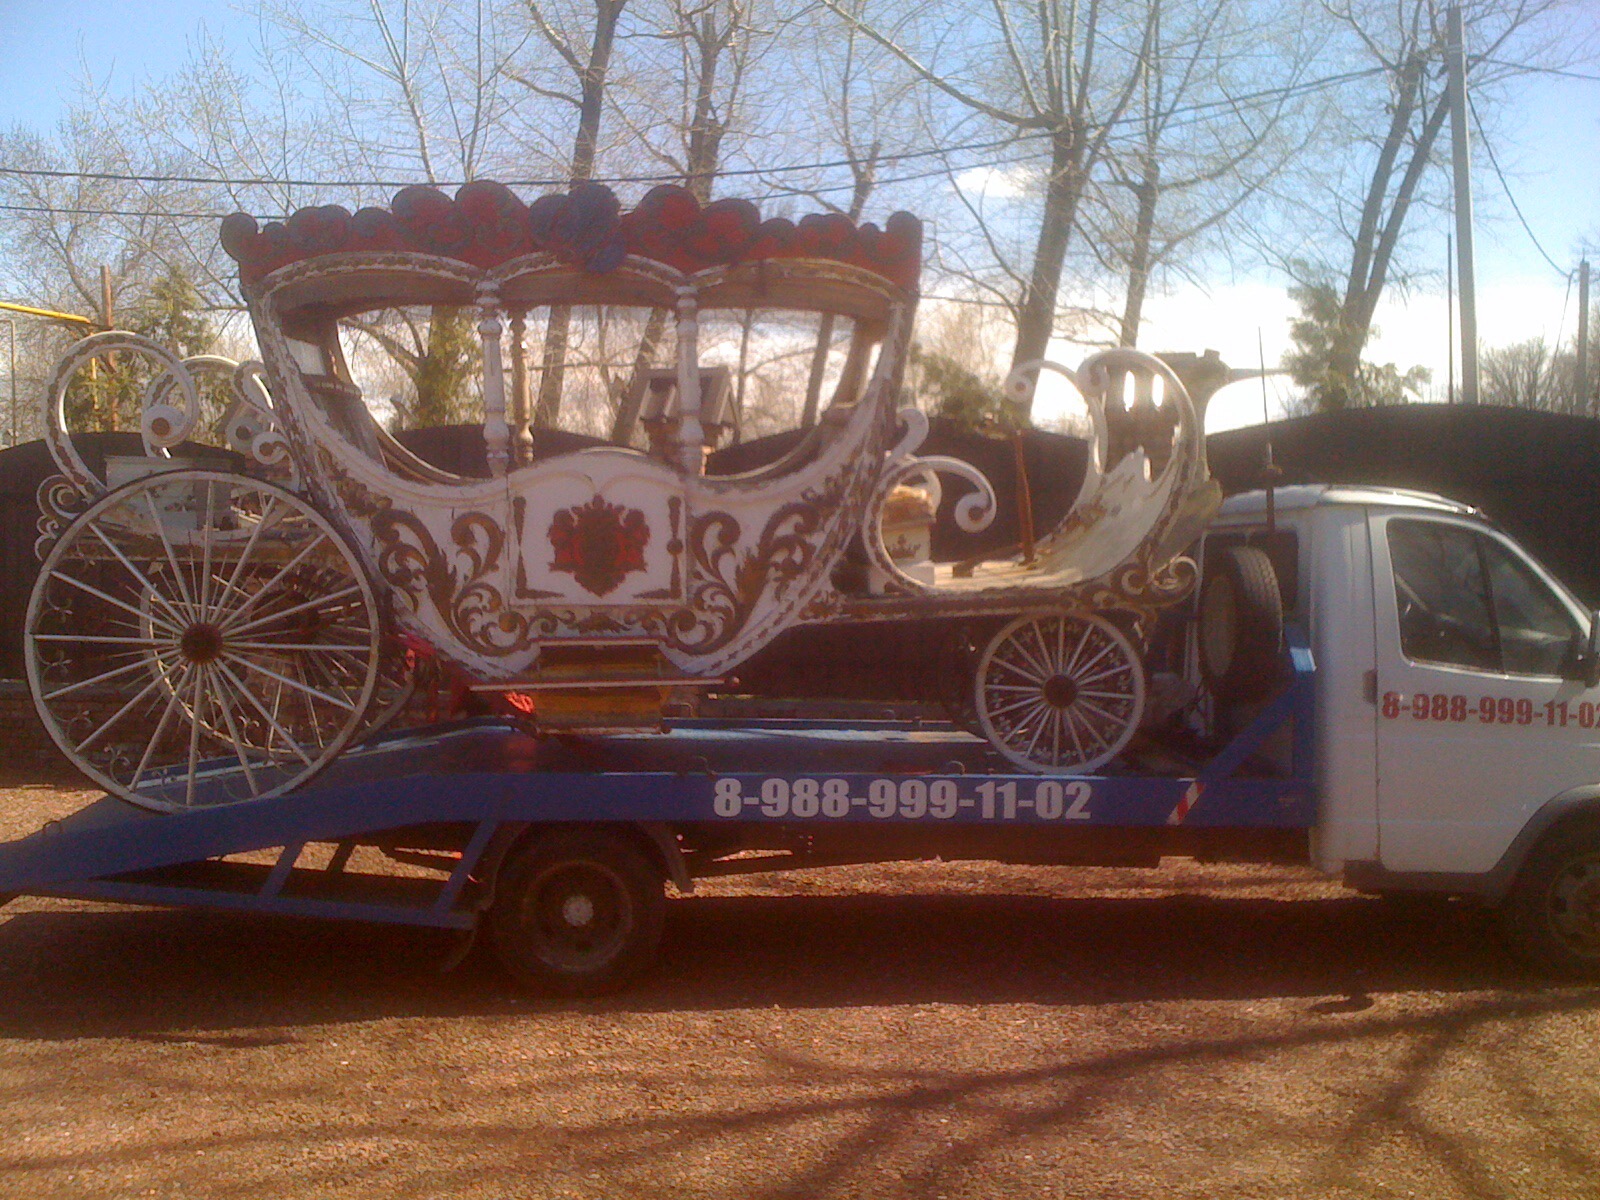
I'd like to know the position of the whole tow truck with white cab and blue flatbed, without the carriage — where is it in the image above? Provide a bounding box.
[0,485,1600,994]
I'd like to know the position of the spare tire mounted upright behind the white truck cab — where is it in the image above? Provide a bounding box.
[1197,546,1283,704]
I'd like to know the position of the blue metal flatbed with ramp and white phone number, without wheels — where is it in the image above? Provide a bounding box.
[0,646,1317,979]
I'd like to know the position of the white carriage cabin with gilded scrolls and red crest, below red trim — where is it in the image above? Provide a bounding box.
[227,185,917,680]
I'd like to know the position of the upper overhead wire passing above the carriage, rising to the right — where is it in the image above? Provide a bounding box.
[0,67,1387,195]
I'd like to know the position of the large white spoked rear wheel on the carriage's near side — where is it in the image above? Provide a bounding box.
[24,470,381,811]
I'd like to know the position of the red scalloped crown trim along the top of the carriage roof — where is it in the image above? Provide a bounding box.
[221,179,922,290]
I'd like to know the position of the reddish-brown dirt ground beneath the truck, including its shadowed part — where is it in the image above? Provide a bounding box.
[0,781,1600,1200]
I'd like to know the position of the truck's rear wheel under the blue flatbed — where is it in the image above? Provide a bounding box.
[490,829,667,995]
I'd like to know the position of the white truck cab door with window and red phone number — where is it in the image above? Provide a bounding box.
[1373,514,1600,872]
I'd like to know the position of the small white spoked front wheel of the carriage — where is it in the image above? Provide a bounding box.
[974,613,1144,771]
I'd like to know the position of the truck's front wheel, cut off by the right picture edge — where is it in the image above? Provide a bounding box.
[1499,818,1600,979]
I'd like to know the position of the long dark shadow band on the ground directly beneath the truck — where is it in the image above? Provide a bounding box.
[0,894,1536,1043]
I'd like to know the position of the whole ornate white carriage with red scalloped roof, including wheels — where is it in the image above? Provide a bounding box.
[26,182,1211,808]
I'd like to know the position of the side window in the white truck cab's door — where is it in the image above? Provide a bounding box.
[1389,520,1578,675]
